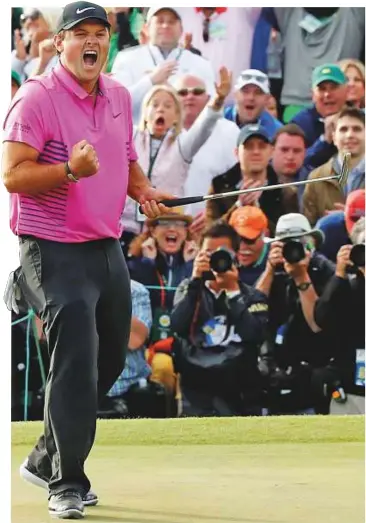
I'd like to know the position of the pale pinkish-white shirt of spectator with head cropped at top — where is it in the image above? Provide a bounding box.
[177,7,262,101]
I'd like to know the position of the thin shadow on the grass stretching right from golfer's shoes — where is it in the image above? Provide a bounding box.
[87,505,281,523]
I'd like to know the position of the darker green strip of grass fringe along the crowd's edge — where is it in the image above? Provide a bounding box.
[12,416,365,446]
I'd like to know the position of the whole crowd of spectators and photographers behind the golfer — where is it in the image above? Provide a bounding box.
[11,7,365,419]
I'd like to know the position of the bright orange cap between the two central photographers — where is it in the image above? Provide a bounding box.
[229,205,268,240]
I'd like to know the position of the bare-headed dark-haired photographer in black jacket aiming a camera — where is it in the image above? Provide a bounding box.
[171,222,268,416]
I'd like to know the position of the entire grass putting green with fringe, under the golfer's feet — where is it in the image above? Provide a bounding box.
[12,416,365,523]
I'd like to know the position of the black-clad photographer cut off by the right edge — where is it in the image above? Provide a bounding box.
[314,218,365,415]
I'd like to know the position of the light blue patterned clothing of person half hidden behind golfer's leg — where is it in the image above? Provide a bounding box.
[107,280,152,397]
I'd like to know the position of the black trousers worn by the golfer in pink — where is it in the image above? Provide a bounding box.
[20,236,131,494]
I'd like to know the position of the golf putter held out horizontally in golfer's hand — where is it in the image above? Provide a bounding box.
[139,153,351,213]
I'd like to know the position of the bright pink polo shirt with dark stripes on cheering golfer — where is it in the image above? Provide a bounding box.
[3,64,137,243]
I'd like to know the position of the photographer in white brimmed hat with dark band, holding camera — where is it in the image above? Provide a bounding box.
[256,213,334,414]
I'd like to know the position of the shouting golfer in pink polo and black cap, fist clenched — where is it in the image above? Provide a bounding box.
[2,2,172,519]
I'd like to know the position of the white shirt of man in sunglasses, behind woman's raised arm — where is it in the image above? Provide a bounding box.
[184,118,240,216]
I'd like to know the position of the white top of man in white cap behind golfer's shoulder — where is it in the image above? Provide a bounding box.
[112,45,215,124]
